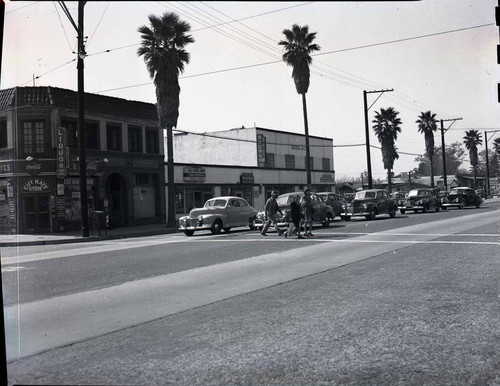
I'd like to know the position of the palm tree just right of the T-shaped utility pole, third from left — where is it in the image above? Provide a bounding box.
[372,107,401,193]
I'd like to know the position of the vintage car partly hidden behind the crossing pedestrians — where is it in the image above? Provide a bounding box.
[254,192,335,228]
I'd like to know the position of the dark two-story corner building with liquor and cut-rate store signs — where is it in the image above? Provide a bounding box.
[0,87,166,233]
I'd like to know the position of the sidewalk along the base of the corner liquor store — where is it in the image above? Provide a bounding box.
[0,224,177,248]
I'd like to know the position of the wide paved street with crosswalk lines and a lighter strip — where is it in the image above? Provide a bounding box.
[2,201,500,385]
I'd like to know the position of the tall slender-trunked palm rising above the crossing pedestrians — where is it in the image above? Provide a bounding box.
[278,24,320,187]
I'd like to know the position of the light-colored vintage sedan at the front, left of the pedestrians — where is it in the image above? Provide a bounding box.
[179,196,257,236]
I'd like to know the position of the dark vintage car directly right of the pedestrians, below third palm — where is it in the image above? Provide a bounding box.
[340,189,398,221]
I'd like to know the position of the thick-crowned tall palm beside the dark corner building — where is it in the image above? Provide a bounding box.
[137,12,194,228]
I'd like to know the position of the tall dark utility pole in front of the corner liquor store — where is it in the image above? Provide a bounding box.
[59,0,89,237]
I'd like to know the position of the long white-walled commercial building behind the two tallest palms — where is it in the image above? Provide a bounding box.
[174,127,335,216]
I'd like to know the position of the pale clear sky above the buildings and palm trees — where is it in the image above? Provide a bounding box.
[0,0,500,179]
